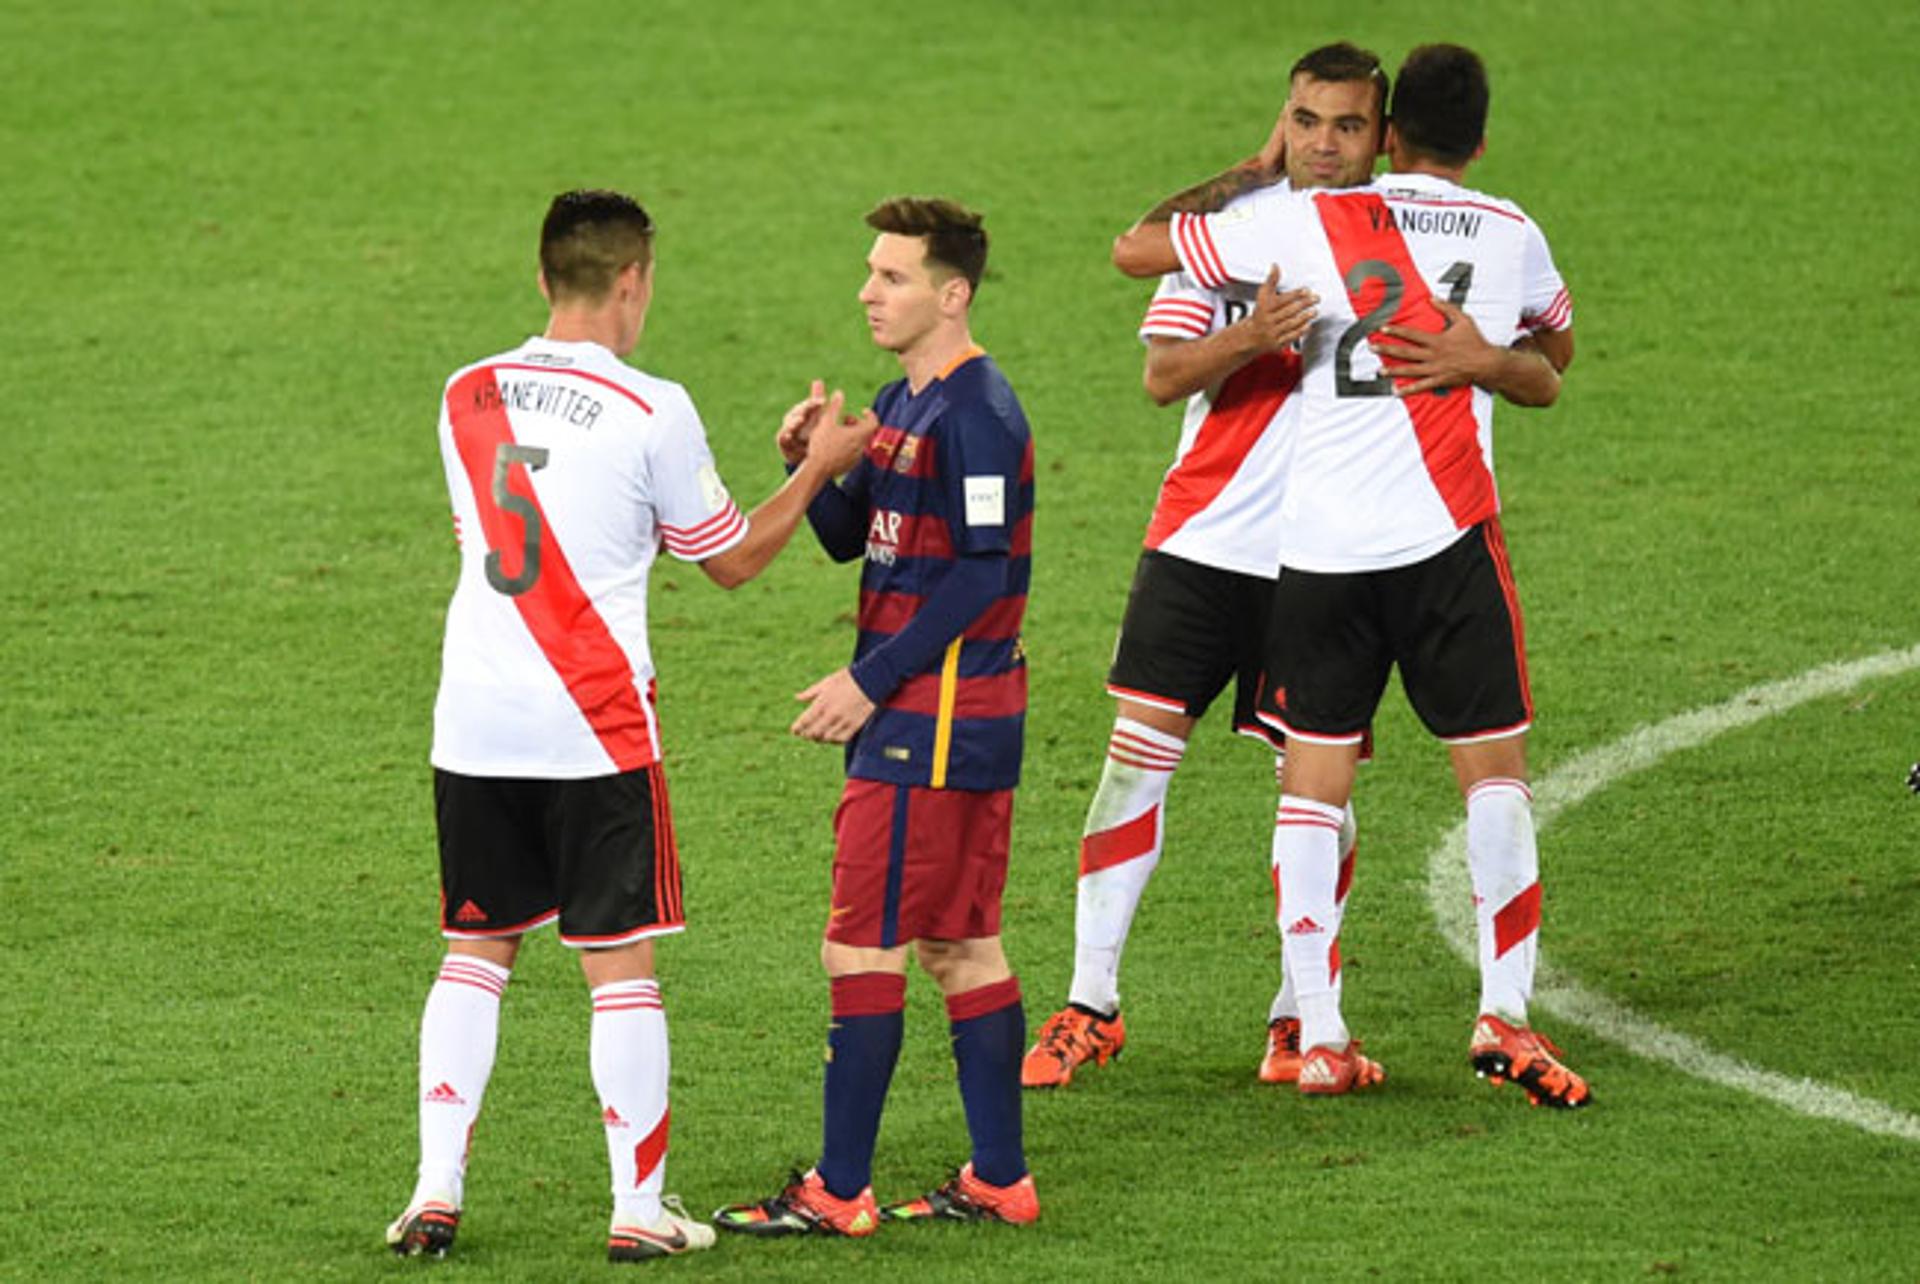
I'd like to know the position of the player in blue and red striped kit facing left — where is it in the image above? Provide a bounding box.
[714,198,1039,1236]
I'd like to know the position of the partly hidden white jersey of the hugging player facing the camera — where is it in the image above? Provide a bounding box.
[1140,261,1300,580]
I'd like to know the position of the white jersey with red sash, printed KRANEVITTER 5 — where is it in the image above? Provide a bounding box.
[432,338,747,779]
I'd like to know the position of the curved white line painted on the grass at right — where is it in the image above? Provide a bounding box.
[1427,645,1920,1142]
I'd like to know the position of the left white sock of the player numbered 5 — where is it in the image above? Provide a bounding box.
[409,954,513,1207]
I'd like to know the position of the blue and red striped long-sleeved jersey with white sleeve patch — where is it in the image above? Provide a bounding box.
[810,349,1033,789]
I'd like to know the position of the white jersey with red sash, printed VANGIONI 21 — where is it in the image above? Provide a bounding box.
[1171,175,1572,572]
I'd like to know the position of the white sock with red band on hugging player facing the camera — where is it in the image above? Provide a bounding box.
[1068,718,1187,1013]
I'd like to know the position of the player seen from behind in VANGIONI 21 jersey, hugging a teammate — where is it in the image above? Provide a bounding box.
[1114,44,1592,1107]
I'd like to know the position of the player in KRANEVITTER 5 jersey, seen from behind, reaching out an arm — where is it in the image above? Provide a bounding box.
[386,192,872,1261]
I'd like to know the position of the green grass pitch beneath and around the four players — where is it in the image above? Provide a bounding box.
[0,0,1920,1280]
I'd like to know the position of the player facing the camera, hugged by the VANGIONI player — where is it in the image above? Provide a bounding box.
[1021,42,1386,1088]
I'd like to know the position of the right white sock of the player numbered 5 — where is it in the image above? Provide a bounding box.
[591,981,672,1226]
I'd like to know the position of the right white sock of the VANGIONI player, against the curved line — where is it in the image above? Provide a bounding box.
[1467,777,1540,1025]
